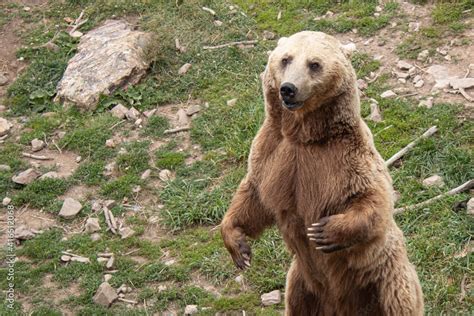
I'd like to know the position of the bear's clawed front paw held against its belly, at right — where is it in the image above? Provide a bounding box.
[307,215,351,253]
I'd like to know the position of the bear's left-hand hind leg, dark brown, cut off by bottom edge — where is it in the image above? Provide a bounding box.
[285,260,322,316]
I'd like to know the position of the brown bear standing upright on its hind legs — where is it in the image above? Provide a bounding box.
[221,31,423,316]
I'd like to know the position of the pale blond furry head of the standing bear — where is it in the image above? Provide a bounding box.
[263,31,356,112]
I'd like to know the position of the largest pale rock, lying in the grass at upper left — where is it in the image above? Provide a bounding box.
[56,20,151,109]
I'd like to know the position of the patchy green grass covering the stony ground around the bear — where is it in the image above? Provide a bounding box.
[0,0,473,315]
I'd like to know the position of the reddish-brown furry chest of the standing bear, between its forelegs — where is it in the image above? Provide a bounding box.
[254,140,351,223]
